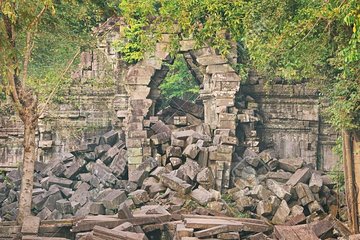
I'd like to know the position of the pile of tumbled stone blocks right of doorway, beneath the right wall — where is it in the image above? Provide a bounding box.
[228,149,347,225]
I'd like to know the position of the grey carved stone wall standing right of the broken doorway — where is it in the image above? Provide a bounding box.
[241,75,339,171]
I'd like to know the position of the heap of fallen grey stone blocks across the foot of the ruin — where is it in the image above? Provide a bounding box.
[0,99,346,239]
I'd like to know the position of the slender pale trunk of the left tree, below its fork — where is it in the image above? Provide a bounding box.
[17,110,38,224]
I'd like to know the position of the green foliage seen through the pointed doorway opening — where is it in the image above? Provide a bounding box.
[160,54,200,106]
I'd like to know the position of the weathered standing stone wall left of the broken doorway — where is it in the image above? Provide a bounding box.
[0,20,124,169]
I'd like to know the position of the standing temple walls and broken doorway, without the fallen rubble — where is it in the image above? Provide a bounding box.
[0,16,337,178]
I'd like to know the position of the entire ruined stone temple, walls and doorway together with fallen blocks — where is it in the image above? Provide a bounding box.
[0,18,350,240]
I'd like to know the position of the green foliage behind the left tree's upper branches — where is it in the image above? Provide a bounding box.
[0,0,119,104]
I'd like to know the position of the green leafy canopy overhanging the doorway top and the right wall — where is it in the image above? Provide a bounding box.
[120,0,360,129]
